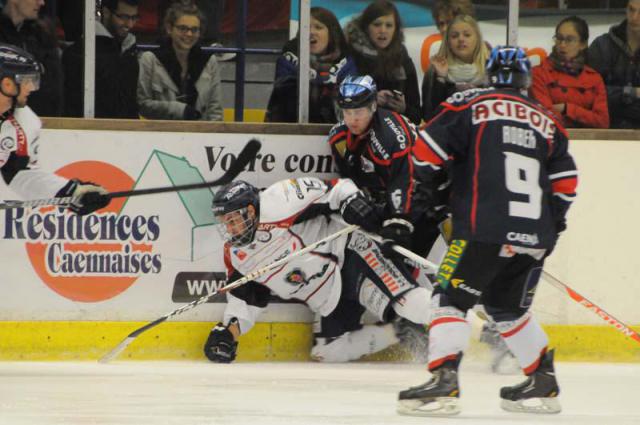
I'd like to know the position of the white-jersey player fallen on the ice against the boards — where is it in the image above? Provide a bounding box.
[204,177,429,363]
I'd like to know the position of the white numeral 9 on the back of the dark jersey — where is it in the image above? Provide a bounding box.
[504,152,542,220]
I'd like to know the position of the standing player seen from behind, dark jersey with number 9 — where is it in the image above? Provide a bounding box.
[398,47,577,415]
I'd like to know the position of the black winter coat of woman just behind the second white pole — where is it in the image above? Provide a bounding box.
[266,38,357,124]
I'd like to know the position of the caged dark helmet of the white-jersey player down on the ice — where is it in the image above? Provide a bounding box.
[211,180,260,247]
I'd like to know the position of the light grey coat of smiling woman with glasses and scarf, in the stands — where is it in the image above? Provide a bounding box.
[138,41,223,121]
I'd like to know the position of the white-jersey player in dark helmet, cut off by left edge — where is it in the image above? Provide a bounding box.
[0,44,109,214]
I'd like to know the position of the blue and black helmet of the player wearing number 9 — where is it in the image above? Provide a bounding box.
[486,46,531,90]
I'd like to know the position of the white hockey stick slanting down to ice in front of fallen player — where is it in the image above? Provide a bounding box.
[98,226,358,363]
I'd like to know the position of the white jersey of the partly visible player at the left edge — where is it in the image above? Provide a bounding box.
[0,106,68,199]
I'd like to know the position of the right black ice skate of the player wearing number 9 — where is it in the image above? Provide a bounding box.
[500,350,562,413]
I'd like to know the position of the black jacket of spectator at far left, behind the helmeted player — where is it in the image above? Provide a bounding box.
[0,13,64,117]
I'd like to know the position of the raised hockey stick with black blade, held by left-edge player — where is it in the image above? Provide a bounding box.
[0,139,261,210]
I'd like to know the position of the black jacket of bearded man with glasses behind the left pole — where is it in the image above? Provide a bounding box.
[62,22,138,119]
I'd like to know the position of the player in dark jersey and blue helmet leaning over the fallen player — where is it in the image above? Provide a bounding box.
[329,76,444,272]
